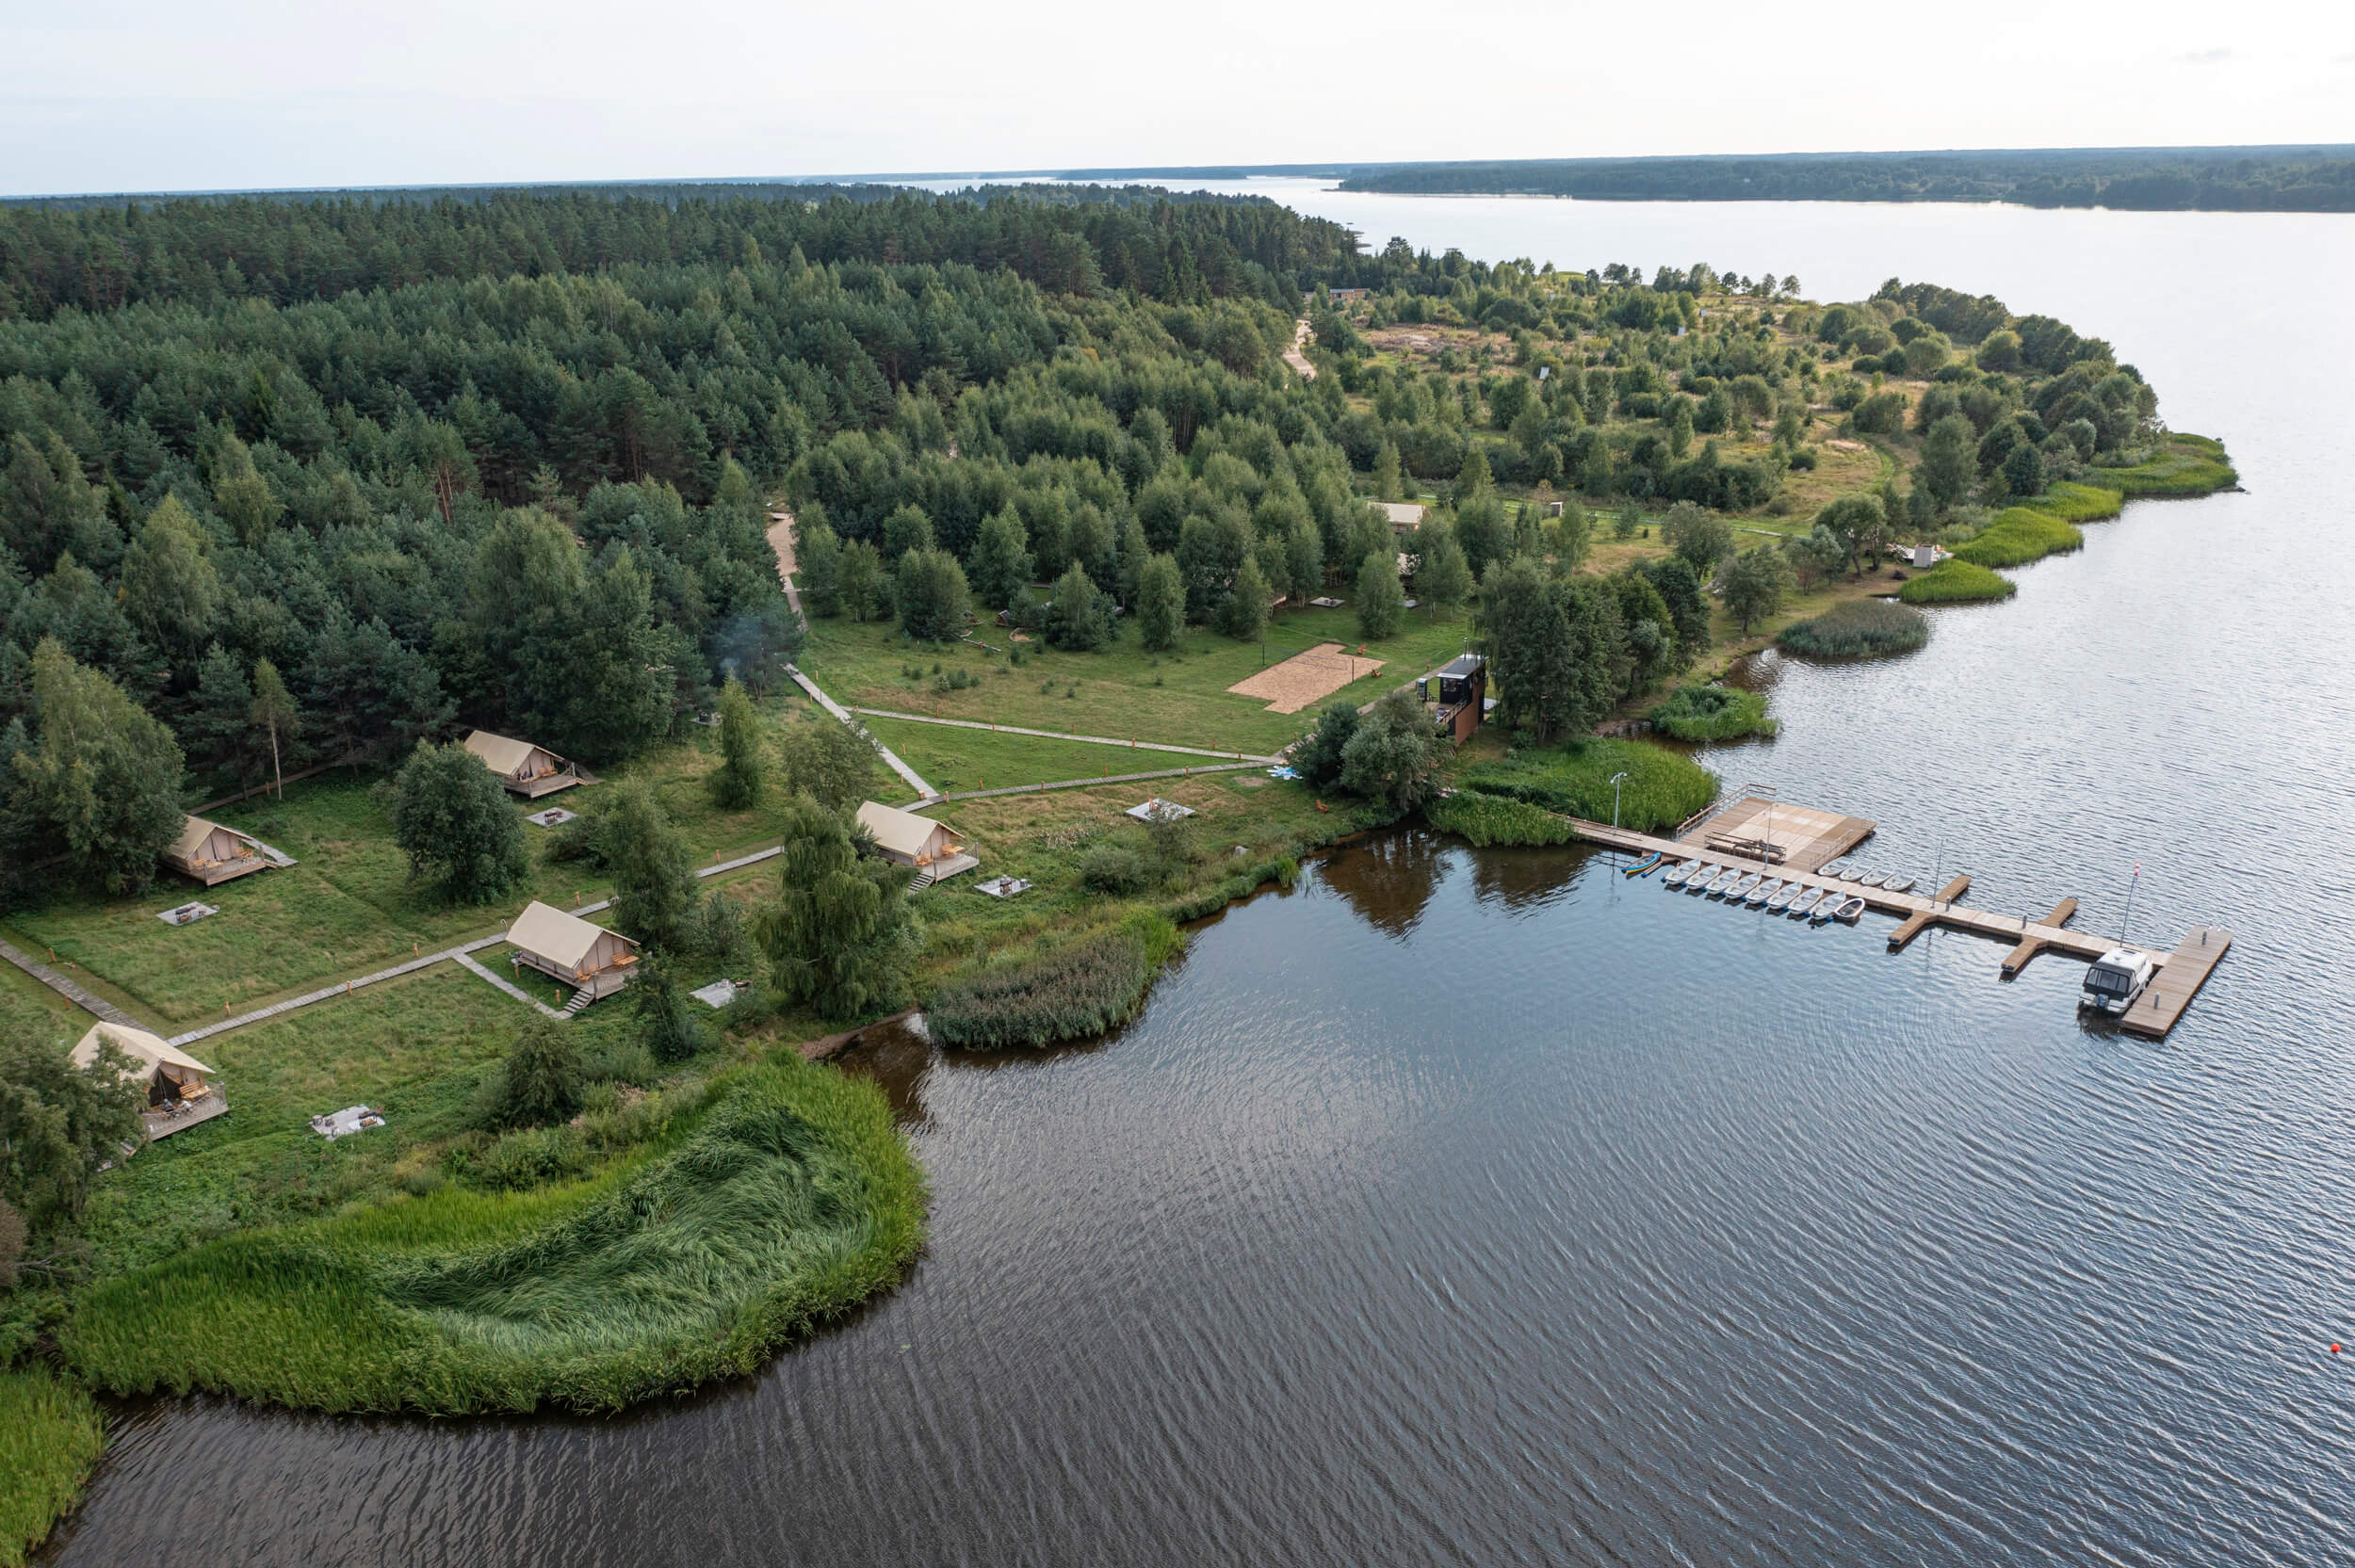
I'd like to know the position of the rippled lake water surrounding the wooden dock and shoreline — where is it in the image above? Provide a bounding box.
[50,186,2355,1568]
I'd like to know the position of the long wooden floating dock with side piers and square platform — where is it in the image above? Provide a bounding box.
[1568,796,2233,1039]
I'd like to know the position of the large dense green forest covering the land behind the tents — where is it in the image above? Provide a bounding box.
[0,176,2155,885]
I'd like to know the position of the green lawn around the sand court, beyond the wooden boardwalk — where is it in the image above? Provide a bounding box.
[804,607,1468,753]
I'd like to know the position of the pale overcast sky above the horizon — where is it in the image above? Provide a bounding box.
[0,0,2355,196]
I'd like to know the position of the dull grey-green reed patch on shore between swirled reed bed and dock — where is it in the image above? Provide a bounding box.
[923,912,1185,1048]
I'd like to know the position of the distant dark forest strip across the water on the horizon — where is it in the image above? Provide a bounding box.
[1340,146,2355,212]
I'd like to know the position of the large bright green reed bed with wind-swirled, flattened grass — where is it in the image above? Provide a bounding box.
[61,1053,926,1415]
